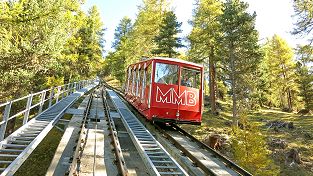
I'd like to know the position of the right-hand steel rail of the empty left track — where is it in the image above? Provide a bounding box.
[101,89,128,176]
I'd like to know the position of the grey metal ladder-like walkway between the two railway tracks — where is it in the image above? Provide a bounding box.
[106,89,188,175]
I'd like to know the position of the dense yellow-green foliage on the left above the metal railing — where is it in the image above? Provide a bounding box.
[0,0,103,102]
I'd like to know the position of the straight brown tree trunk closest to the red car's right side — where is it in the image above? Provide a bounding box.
[209,46,216,114]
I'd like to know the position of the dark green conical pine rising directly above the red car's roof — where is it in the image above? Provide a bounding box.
[152,11,183,58]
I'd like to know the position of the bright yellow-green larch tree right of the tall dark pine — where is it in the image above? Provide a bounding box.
[264,35,298,111]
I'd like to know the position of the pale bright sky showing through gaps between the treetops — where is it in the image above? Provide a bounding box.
[83,0,305,51]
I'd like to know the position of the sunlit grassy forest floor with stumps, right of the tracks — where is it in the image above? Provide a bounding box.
[182,99,313,176]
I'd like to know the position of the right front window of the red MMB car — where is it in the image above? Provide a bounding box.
[180,68,201,89]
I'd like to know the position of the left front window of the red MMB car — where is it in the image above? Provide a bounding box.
[154,63,178,84]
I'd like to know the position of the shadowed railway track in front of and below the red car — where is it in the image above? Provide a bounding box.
[155,124,252,176]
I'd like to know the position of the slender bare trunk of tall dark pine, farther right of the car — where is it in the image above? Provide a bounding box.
[229,43,238,127]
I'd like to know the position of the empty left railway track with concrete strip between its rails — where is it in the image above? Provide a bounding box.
[65,88,124,175]
